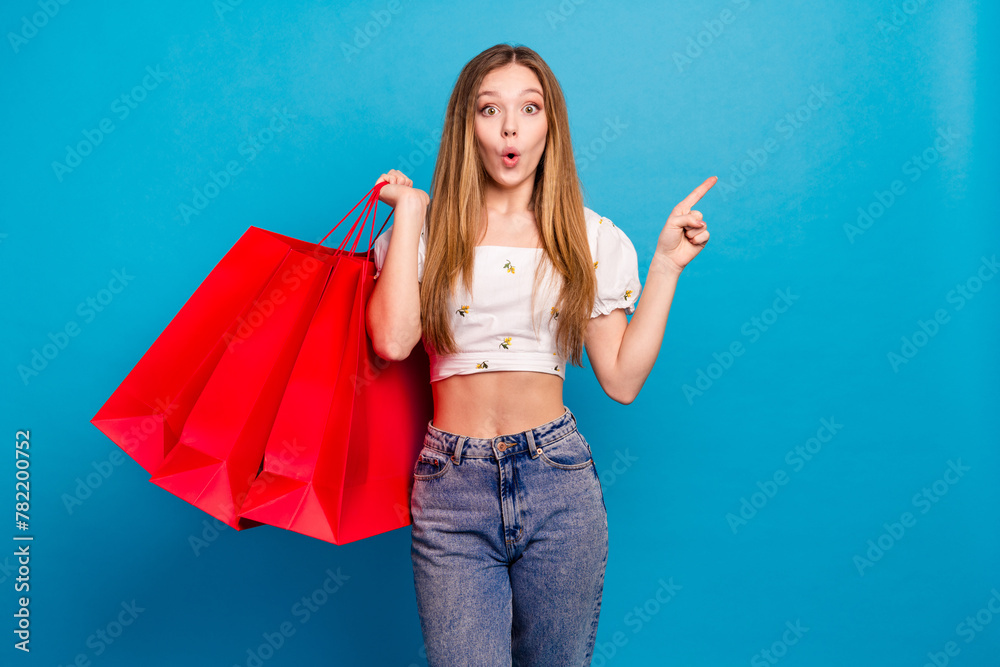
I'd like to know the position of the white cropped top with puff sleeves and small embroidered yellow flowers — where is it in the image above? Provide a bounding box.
[372,207,642,382]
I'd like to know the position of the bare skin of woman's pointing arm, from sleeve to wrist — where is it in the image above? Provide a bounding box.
[584,252,681,405]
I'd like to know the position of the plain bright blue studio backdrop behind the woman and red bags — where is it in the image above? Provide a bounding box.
[0,0,1000,667]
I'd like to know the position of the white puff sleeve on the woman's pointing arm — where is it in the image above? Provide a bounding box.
[590,217,642,317]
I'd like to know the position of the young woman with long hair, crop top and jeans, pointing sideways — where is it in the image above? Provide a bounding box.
[367,44,715,667]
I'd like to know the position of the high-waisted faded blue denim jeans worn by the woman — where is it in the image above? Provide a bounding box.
[410,406,608,667]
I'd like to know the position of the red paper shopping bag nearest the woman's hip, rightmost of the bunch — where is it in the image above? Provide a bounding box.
[240,194,432,544]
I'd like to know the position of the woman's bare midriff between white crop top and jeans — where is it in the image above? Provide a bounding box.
[431,371,566,438]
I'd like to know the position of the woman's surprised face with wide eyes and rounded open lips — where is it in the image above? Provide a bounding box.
[475,64,548,188]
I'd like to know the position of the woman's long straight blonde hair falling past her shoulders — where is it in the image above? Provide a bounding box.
[420,44,597,366]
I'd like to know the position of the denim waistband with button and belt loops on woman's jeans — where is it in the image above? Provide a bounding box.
[424,405,577,464]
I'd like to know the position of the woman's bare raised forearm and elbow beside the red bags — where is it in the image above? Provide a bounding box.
[365,190,428,361]
